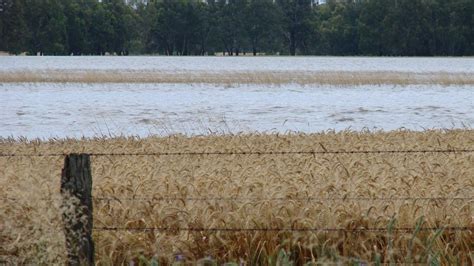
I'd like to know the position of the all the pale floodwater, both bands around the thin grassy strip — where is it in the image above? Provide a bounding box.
[0,57,474,138]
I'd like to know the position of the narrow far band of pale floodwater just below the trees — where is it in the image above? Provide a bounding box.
[0,56,474,73]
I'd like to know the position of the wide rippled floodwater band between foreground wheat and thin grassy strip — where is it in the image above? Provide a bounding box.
[0,84,474,138]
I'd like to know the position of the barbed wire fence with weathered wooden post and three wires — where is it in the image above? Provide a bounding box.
[0,149,474,265]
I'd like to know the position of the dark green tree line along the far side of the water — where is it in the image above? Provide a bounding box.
[0,0,474,56]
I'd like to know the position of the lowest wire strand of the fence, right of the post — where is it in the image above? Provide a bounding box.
[92,226,474,232]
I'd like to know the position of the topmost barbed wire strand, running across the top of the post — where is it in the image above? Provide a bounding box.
[0,149,474,157]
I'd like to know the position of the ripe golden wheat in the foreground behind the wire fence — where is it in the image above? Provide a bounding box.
[0,130,474,265]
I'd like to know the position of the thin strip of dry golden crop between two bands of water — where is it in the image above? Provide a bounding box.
[0,70,474,86]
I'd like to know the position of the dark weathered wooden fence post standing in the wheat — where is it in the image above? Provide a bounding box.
[61,154,94,265]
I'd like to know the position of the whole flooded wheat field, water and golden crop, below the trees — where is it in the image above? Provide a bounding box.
[0,57,474,265]
